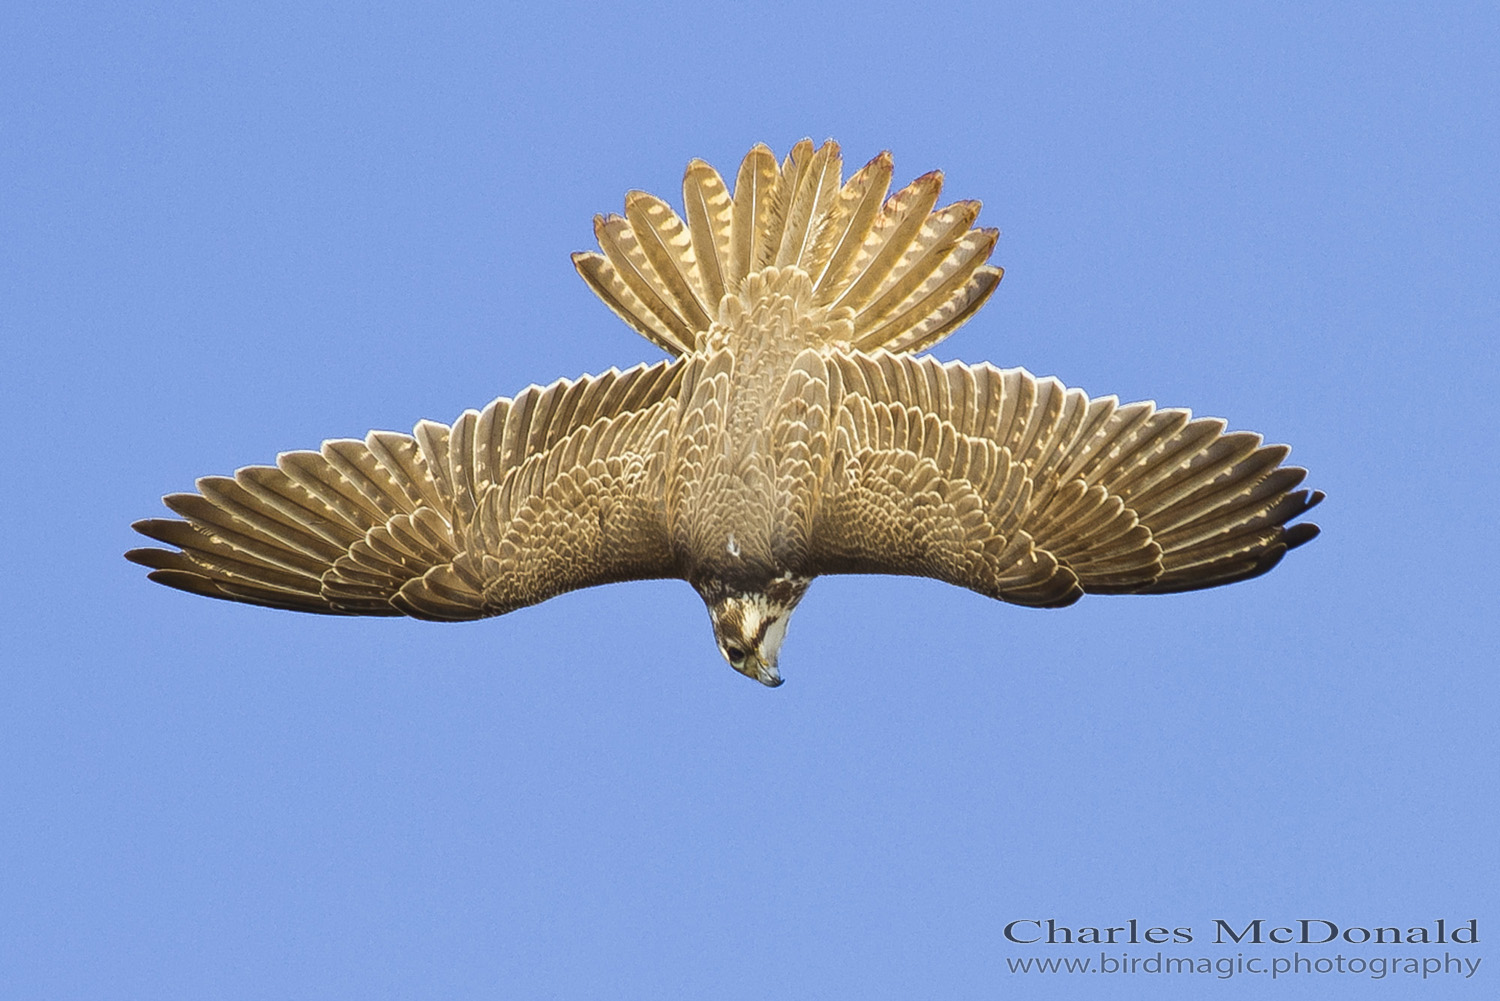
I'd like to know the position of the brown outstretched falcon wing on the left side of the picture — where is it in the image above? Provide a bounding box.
[126,362,684,620]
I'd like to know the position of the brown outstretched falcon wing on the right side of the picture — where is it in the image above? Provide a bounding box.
[800,353,1323,606]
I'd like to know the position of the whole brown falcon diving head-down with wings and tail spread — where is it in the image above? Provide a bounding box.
[126,140,1323,686]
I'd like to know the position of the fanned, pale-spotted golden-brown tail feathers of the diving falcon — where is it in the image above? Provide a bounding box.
[573,140,1002,354]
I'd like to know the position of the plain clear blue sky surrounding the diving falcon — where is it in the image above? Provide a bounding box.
[0,2,1500,999]
